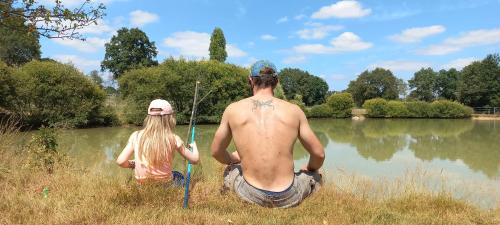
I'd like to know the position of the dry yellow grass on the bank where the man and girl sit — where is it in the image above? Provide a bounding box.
[0,121,500,225]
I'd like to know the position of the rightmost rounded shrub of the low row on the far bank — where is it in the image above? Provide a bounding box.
[430,100,472,118]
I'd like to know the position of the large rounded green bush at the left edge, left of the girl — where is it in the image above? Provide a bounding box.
[0,61,116,127]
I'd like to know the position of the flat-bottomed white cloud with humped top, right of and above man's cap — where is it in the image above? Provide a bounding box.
[293,32,373,54]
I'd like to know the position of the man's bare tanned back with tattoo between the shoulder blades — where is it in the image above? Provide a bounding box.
[224,97,303,191]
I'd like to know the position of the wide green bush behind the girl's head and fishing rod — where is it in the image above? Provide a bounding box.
[118,58,250,125]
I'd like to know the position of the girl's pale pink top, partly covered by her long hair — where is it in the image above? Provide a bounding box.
[132,131,182,181]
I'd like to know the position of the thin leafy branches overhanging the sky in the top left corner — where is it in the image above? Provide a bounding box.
[0,0,106,40]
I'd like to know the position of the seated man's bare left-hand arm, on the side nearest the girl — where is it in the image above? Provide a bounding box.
[211,105,240,164]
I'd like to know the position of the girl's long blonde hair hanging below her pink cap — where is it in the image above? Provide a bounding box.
[138,114,177,167]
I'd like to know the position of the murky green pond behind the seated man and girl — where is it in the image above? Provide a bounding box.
[23,119,500,207]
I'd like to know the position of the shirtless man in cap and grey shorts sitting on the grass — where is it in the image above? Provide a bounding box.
[211,60,325,208]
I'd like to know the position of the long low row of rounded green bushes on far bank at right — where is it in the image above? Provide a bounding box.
[363,98,472,118]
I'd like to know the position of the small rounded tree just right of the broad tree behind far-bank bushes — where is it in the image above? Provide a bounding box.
[408,68,437,102]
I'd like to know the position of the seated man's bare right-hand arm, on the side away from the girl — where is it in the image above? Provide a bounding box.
[299,109,325,171]
